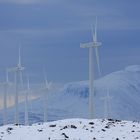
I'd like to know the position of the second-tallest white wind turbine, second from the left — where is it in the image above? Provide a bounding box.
[8,47,25,124]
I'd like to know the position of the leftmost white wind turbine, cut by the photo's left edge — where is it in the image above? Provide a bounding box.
[0,70,11,125]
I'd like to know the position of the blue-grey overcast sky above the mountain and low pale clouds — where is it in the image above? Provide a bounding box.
[0,0,140,82]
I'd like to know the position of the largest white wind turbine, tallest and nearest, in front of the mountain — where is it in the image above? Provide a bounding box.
[80,18,102,119]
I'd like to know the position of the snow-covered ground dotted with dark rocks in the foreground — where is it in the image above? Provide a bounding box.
[0,119,140,140]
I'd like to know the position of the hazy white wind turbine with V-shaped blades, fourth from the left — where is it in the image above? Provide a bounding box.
[44,71,52,122]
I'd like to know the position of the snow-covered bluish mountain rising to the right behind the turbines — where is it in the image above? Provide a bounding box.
[0,65,140,123]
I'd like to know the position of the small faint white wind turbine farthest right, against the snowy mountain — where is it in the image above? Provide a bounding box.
[101,90,112,119]
